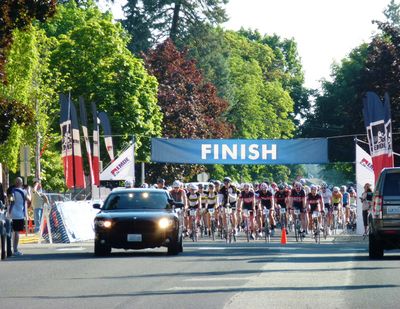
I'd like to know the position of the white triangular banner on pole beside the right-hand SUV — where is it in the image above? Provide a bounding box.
[356,144,375,234]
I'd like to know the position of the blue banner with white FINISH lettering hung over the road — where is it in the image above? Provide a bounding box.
[151,138,329,164]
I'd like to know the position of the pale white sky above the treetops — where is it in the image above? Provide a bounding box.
[103,0,390,88]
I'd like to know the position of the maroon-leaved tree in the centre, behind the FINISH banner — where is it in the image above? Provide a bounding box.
[145,39,231,183]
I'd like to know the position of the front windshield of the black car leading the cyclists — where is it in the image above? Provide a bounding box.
[103,191,169,210]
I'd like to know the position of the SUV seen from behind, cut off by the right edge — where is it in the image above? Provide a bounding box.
[369,168,400,259]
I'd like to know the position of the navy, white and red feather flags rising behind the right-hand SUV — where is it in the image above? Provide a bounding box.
[363,92,393,181]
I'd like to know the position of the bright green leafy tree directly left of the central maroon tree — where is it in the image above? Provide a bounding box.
[43,1,162,160]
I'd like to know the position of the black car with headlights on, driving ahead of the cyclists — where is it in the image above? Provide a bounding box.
[93,189,183,256]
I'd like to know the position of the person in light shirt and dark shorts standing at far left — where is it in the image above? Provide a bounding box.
[8,177,29,256]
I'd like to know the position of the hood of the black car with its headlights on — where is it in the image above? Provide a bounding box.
[96,209,177,219]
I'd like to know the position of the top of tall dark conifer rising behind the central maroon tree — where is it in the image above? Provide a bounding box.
[123,0,228,53]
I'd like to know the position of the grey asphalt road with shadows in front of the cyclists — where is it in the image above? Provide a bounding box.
[0,232,400,309]
